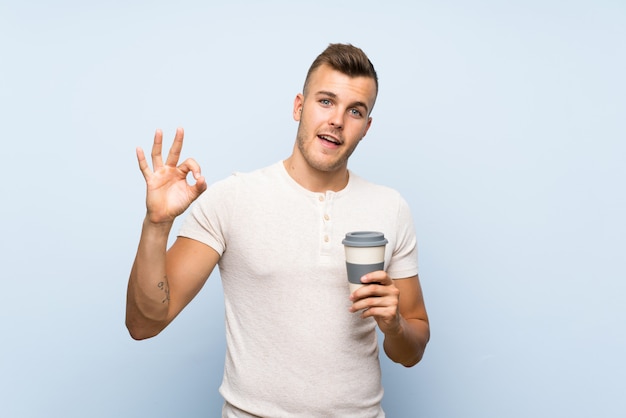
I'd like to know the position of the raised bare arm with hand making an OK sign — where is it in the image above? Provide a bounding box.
[126,128,219,339]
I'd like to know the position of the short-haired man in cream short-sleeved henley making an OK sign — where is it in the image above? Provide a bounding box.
[126,44,429,418]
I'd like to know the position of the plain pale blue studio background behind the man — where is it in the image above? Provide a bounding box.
[0,0,626,418]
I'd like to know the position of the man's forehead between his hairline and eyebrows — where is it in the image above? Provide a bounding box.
[304,65,376,109]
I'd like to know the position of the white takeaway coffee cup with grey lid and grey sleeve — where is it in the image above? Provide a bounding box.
[342,231,387,293]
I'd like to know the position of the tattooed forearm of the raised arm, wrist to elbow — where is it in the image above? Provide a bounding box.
[126,219,172,339]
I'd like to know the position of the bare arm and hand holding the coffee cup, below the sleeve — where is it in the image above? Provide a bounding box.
[351,271,430,367]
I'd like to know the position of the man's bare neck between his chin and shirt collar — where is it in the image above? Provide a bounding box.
[283,154,349,193]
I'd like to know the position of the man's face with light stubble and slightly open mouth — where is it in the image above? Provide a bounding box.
[293,65,376,172]
